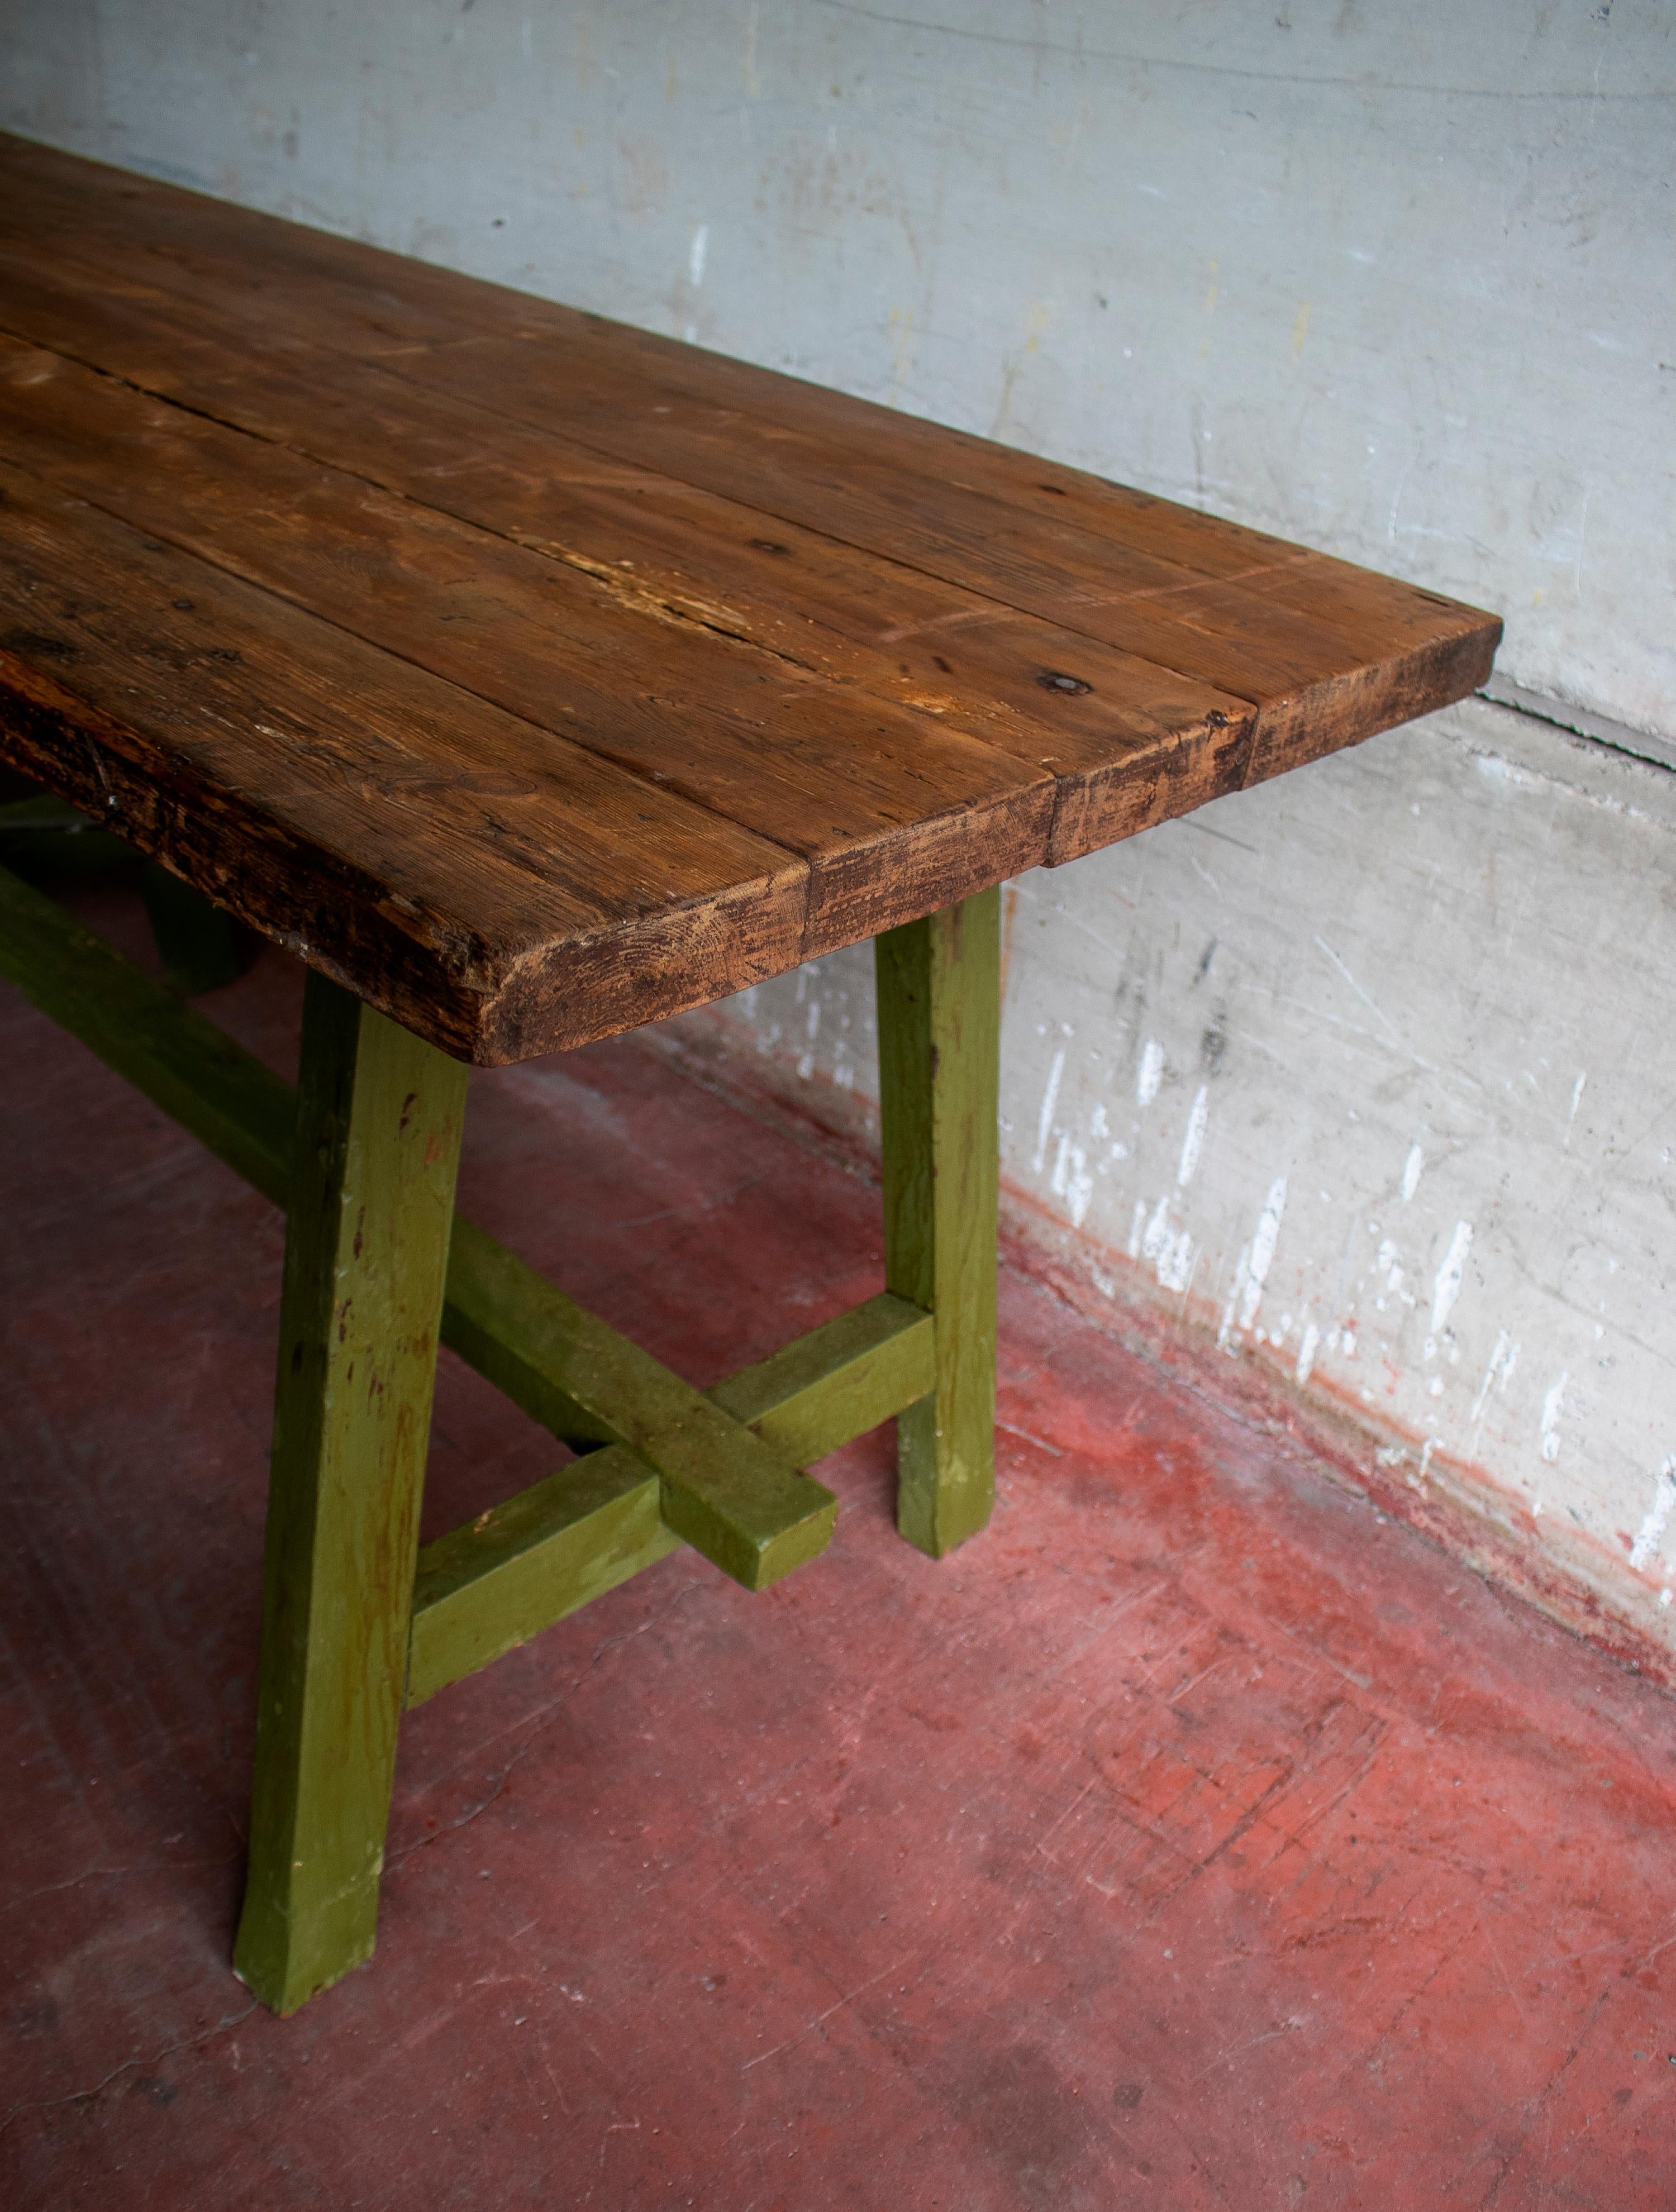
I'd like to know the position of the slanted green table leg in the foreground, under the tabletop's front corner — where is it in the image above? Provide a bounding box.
[235,975,466,2013]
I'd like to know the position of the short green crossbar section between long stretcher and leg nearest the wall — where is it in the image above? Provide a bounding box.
[706,1292,935,1466]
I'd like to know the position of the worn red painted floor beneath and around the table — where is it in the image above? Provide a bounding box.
[0,900,1676,2212]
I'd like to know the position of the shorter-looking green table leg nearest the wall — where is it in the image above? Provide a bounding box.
[875,889,1002,1560]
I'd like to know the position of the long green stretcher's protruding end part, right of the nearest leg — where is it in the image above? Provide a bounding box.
[445,1221,838,1590]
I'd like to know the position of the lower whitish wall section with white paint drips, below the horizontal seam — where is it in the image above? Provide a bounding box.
[689,701,1676,1650]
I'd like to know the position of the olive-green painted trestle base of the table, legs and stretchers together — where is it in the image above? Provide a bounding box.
[0,869,997,2011]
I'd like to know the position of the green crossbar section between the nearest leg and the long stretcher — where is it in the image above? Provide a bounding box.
[407,1445,681,1705]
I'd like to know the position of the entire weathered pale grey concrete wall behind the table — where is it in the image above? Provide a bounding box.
[0,0,1676,1655]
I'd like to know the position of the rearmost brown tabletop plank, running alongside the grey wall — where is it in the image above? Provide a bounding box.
[0,154,1491,717]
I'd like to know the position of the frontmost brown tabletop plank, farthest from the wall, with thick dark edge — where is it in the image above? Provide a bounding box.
[0,465,807,1062]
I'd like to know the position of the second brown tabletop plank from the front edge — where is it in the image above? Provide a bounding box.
[0,350,1055,949]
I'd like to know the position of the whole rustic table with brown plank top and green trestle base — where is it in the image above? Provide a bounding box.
[0,139,1499,2011]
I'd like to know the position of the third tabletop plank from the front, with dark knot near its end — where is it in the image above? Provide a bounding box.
[0,248,1251,858]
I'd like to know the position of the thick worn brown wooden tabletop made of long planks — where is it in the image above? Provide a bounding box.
[0,137,1499,1062]
